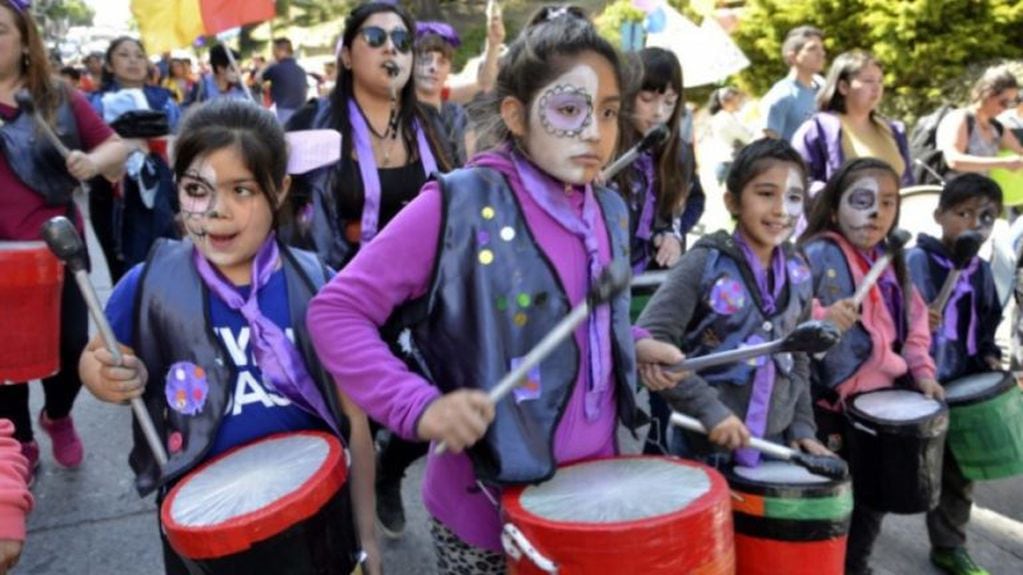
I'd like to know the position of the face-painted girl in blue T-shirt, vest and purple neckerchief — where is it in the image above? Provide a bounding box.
[79,99,380,574]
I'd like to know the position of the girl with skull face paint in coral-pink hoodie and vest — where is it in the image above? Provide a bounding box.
[800,158,943,573]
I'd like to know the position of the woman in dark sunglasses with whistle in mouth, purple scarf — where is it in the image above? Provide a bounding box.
[286,2,449,268]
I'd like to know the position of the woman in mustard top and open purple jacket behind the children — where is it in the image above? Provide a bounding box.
[792,50,915,192]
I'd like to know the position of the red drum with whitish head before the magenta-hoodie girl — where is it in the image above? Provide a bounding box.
[501,456,736,575]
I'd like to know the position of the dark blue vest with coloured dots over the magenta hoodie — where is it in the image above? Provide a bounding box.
[402,168,635,483]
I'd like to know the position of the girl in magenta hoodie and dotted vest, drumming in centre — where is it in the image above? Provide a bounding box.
[309,10,681,574]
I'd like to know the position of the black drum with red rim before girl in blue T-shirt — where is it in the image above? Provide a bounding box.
[160,431,359,575]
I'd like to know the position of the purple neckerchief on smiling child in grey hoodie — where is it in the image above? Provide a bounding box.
[733,230,788,468]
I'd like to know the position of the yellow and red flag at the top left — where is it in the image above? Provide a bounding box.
[131,0,274,54]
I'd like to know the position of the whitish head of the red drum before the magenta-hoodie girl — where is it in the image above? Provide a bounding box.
[520,457,711,523]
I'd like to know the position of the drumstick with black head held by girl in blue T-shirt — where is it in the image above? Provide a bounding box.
[42,216,167,467]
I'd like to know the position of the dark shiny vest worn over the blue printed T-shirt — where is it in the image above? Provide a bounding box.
[129,239,348,496]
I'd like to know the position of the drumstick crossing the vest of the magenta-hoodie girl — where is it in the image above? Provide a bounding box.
[434,264,631,455]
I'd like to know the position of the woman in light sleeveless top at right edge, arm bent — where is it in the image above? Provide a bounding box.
[936,67,1023,177]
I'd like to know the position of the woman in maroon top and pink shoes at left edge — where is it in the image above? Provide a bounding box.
[0,0,128,479]
